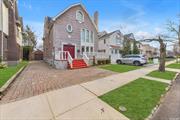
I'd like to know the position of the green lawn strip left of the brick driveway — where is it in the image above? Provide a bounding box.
[0,61,28,87]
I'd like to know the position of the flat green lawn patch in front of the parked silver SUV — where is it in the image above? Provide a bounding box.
[100,64,142,73]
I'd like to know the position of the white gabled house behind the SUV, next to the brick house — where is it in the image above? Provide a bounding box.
[98,30,124,56]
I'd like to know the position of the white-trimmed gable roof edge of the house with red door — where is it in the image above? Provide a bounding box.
[52,3,98,31]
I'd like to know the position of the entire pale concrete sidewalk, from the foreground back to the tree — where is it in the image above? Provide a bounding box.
[0,62,176,120]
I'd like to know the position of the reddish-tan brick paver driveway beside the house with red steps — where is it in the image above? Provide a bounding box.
[0,61,115,103]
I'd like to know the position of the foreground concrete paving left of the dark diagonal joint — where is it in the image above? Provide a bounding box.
[0,85,128,120]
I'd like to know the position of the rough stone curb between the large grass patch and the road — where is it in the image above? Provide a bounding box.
[145,73,180,120]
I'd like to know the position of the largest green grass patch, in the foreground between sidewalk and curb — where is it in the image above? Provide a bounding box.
[99,78,167,120]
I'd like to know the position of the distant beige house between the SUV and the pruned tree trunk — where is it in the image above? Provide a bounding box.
[138,43,160,59]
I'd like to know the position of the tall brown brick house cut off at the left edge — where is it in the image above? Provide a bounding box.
[0,0,22,65]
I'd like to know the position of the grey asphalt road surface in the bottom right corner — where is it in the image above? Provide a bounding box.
[152,75,180,120]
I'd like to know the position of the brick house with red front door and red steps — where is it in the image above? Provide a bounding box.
[43,3,98,69]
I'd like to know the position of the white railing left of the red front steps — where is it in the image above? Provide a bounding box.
[55,51,73,68]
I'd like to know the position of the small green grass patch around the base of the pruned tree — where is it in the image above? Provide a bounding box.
[147,70,176,80]
